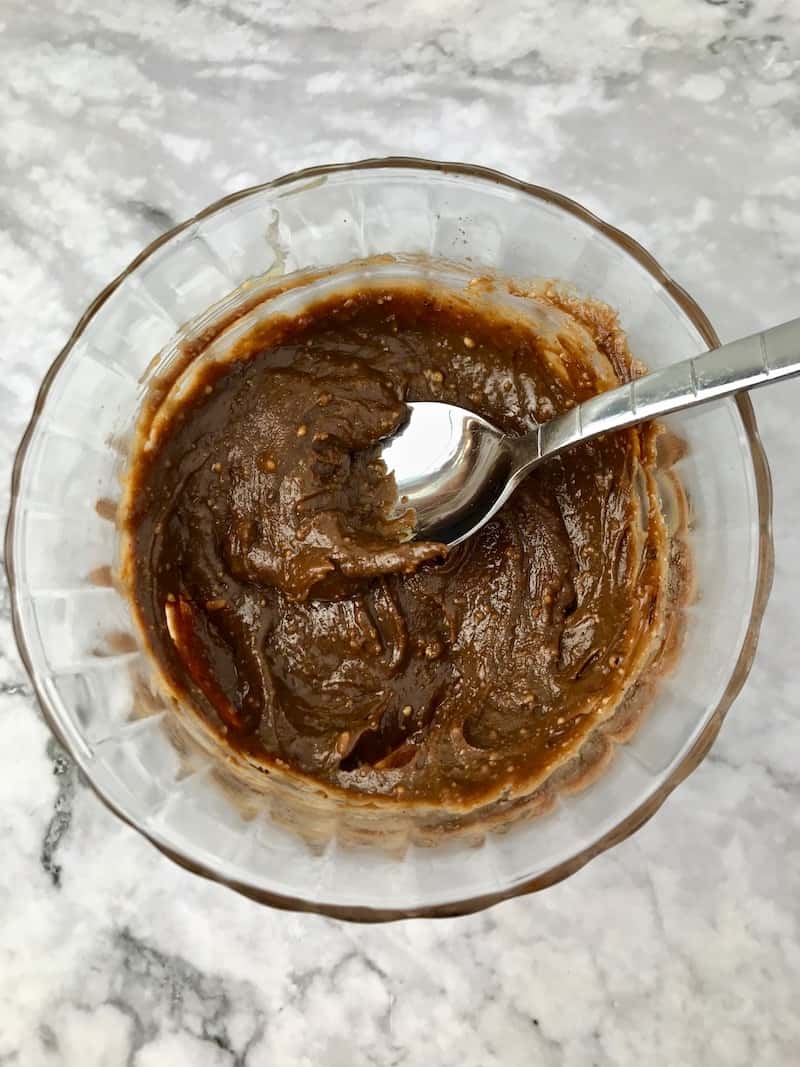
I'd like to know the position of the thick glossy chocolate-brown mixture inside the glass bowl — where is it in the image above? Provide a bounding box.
[126,283,686,810]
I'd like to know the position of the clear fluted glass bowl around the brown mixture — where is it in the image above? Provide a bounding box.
[6,159,772,920]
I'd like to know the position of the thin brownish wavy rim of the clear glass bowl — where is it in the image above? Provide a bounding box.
[4,156,774,922]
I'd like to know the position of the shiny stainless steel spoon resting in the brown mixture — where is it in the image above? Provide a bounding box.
[381,319,800,546]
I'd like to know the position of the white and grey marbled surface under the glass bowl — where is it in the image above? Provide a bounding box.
[0,0,800,1067]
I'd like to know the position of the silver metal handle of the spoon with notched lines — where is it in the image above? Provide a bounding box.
[526,319,800,474]
